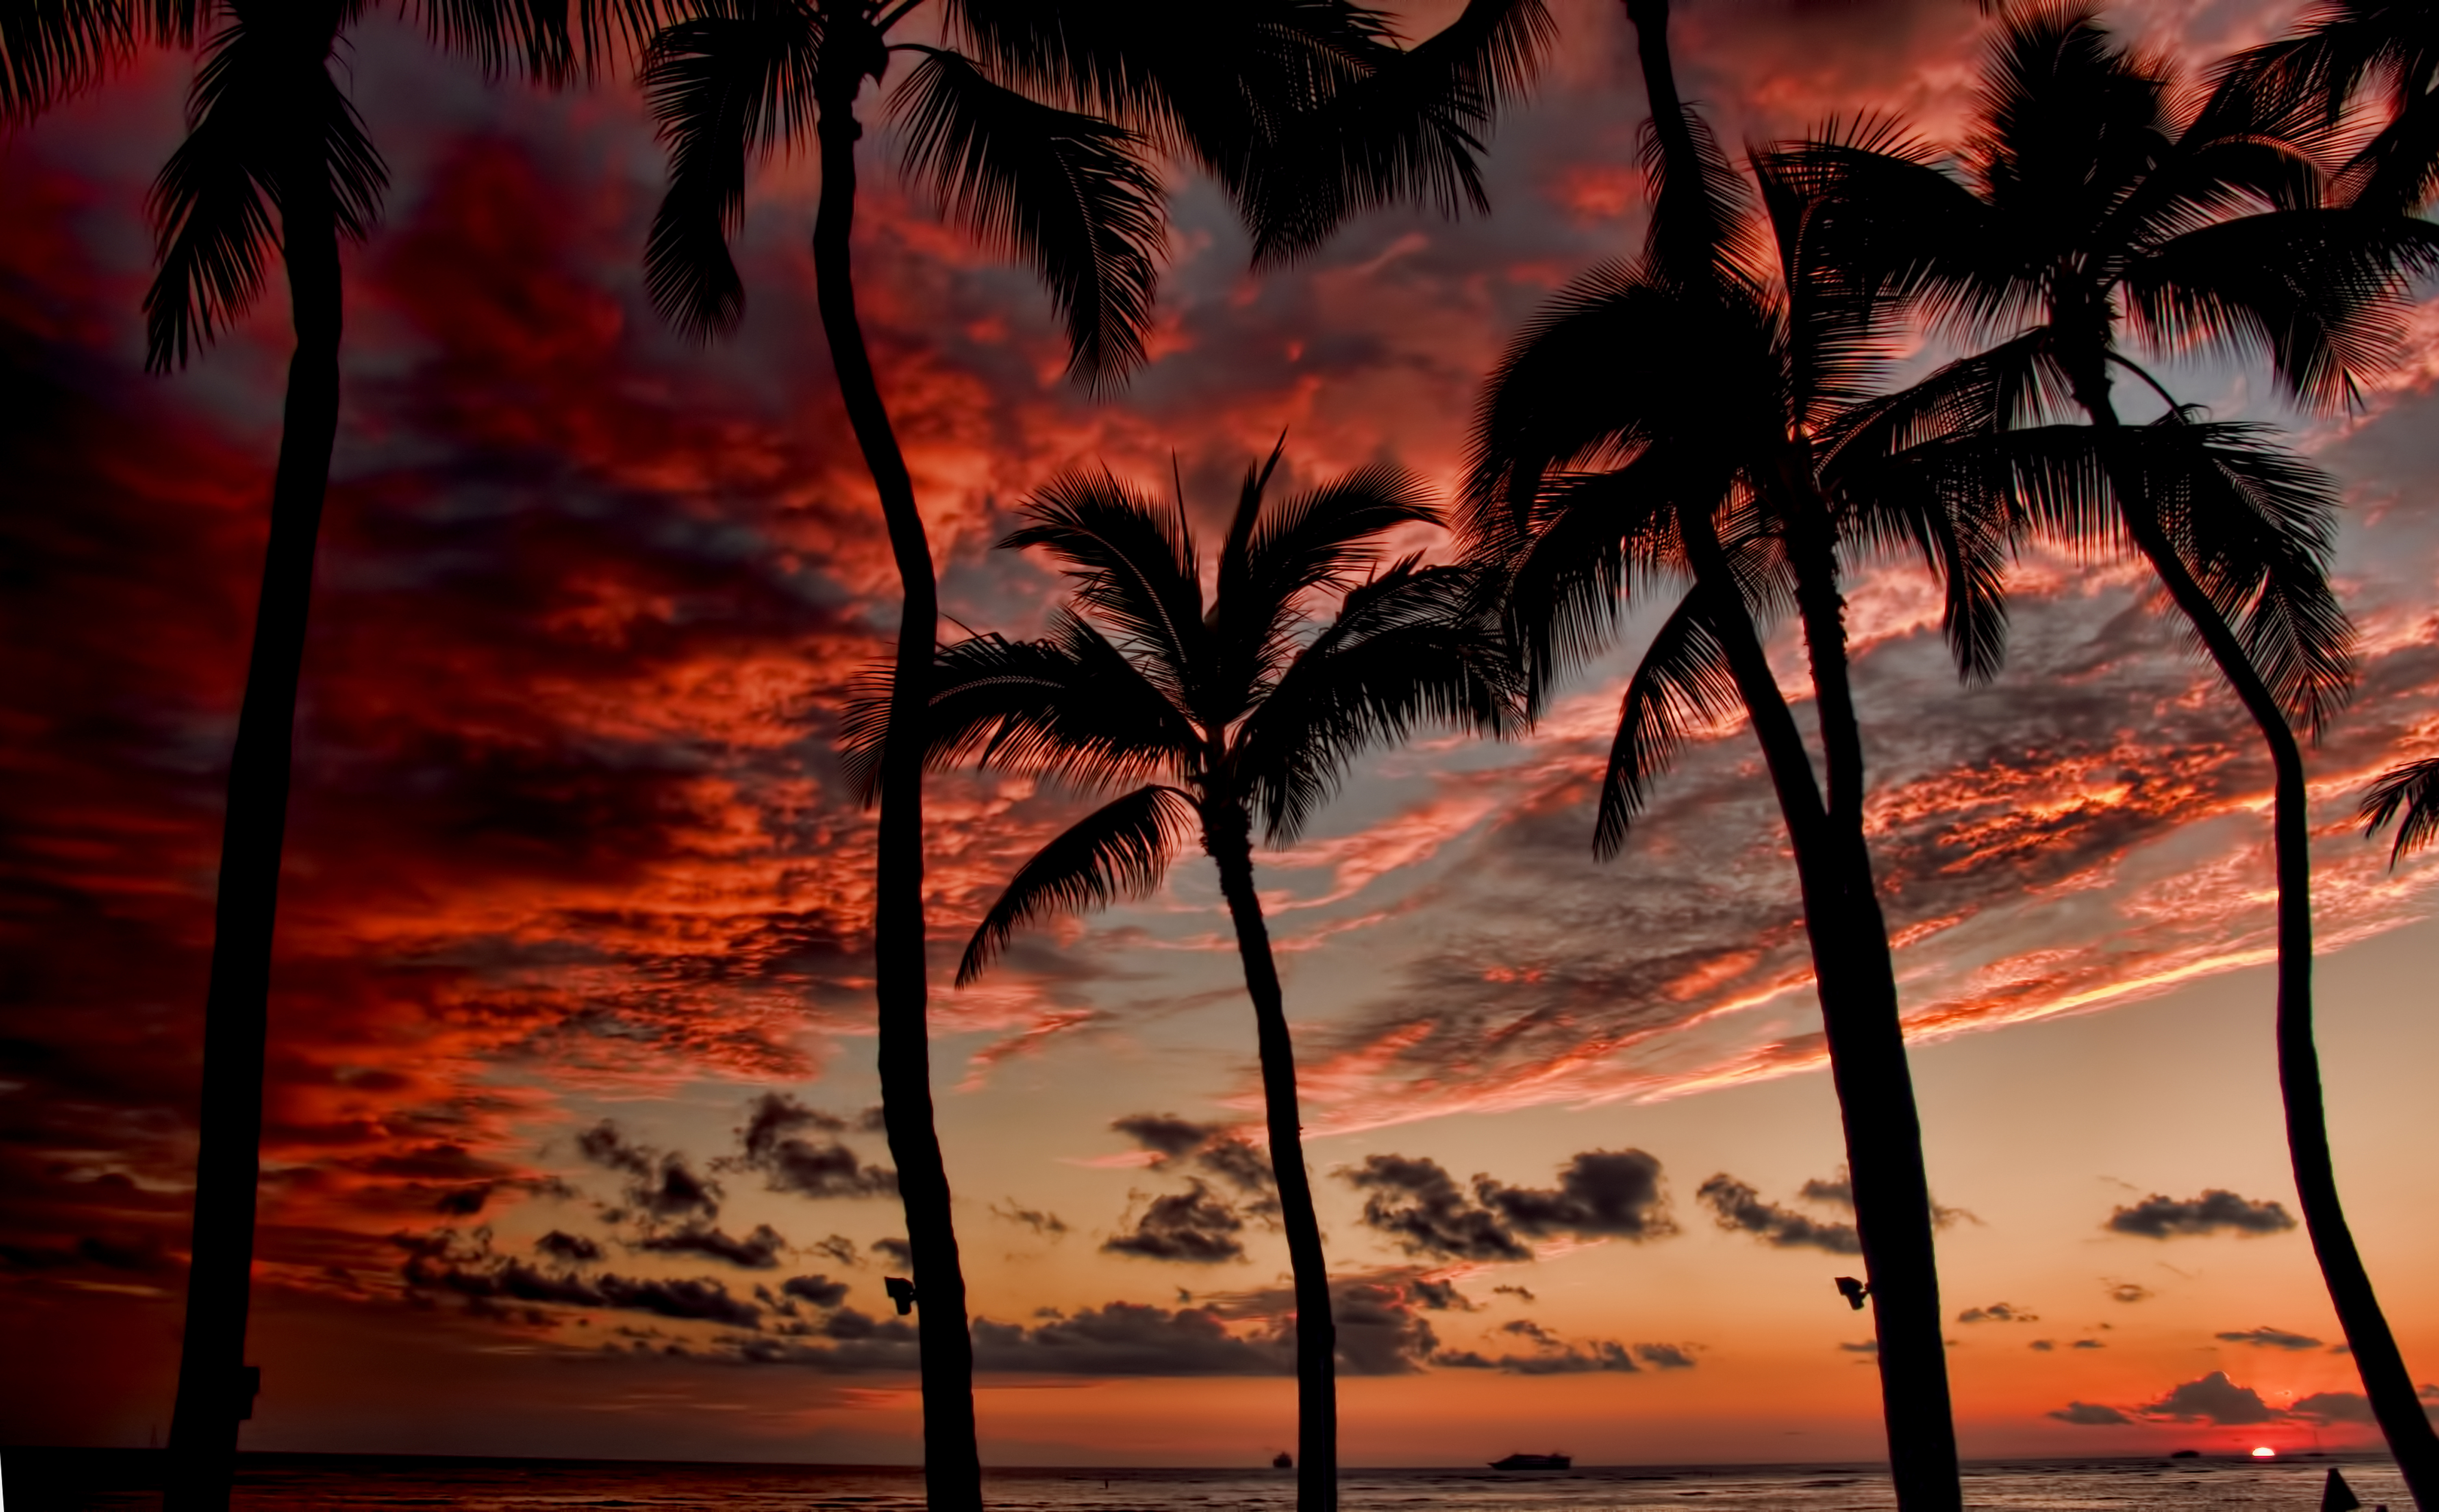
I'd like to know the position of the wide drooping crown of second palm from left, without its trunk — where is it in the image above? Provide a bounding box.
[644,0,1549,383]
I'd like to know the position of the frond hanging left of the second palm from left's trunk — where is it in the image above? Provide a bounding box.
[641,0,822,341]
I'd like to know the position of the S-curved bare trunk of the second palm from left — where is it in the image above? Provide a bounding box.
[812,47,983,1512]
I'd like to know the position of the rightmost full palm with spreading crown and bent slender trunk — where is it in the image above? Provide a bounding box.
[1795,5,2439,1507]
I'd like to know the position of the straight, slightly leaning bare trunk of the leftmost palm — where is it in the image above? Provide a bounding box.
[166,163,341,1512]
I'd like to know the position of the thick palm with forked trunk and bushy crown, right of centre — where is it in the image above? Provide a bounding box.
[1466,0,2022,1512]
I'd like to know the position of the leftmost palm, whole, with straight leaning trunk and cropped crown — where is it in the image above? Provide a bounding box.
[57,0,620,1512]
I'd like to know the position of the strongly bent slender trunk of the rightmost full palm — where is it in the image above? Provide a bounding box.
[2076,358,2439,1512]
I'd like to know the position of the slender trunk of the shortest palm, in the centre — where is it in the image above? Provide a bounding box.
[1202,800,1339,1512]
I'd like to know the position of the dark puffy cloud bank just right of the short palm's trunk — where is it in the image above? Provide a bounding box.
[1339,1149,1676,1261]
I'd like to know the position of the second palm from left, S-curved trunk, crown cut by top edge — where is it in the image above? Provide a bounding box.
[644,0,1549,1510]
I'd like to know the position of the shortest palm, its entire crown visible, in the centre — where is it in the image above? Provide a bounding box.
[849,449,1512,1512]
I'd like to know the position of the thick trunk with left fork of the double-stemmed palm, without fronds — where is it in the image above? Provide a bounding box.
[1683,510,1963,1512]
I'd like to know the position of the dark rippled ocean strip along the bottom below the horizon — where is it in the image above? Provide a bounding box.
[0,1451,2412,1512]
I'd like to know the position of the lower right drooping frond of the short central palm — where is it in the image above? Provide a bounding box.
[1229,558,1522,841]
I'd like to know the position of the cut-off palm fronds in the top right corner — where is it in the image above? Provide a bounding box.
[2232,0,2439,215]
